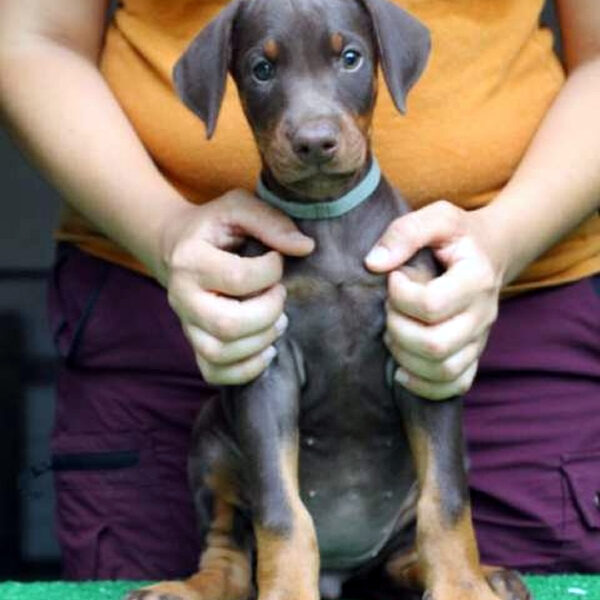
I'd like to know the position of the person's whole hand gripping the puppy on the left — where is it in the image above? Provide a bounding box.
[156,189,314,385]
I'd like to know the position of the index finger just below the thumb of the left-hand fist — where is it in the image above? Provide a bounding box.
[191,244,283,297]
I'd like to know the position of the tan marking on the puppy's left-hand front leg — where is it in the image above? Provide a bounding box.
[254,441,319,600]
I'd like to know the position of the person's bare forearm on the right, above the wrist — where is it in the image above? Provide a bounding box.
[481,58,600,284]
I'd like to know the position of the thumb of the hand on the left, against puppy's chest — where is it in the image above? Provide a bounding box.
[223,189,315,256]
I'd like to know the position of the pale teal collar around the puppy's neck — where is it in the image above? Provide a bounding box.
[256,158,381,219]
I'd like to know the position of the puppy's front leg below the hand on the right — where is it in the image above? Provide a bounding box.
[395,387,498,600]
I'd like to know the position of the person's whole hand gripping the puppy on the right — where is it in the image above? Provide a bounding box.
[365,201,505,400]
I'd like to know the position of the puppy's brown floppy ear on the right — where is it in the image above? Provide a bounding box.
[362,0,431,113]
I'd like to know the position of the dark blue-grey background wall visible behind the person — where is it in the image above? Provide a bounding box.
[0,0,555,579]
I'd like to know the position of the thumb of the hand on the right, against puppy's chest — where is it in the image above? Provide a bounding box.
[365,200,462,273]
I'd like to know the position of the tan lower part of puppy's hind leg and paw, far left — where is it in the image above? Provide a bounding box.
[126,496,252,600]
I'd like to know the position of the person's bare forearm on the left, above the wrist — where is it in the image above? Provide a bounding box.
[0,39,185,279]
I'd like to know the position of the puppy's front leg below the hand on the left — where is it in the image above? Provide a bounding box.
[233,344,319,600]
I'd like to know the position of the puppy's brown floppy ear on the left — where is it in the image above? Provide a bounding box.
[173,0,240,138]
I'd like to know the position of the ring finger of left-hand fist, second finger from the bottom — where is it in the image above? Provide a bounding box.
[185,314,288,366]
